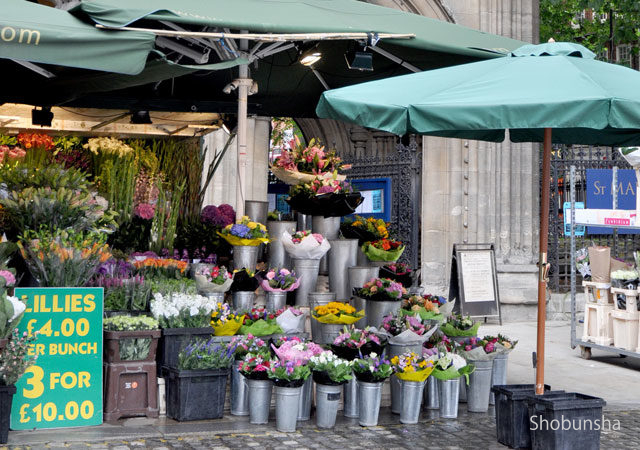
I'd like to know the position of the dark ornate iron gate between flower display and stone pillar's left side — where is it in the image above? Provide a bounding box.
[340,133,422,267]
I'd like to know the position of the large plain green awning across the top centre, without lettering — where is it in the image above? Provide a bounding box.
[72,0,523,58]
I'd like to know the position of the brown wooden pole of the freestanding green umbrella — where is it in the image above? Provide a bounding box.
[536,128,551,395]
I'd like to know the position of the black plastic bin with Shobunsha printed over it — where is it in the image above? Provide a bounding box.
[526,392,606,450]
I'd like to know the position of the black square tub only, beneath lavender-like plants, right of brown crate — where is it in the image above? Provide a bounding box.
[165,367,230,422]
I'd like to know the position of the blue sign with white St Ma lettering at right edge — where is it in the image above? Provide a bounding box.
[587,169,640,234]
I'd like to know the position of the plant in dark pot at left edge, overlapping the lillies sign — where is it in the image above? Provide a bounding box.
[0,328,37,444]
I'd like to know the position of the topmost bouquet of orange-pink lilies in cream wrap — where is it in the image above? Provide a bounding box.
[270,137,351,185]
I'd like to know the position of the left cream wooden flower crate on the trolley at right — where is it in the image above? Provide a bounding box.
[582,281,614,345]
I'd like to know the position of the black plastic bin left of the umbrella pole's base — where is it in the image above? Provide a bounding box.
[491,384,552,448]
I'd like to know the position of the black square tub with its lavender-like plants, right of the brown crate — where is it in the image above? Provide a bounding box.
[167,338,235,421]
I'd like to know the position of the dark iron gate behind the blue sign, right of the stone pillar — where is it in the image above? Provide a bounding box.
[540,145,640,292]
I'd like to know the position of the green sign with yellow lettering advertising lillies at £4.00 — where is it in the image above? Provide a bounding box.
[11,288,103,430]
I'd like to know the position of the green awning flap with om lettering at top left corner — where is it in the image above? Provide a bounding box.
[0,0,155,75]
